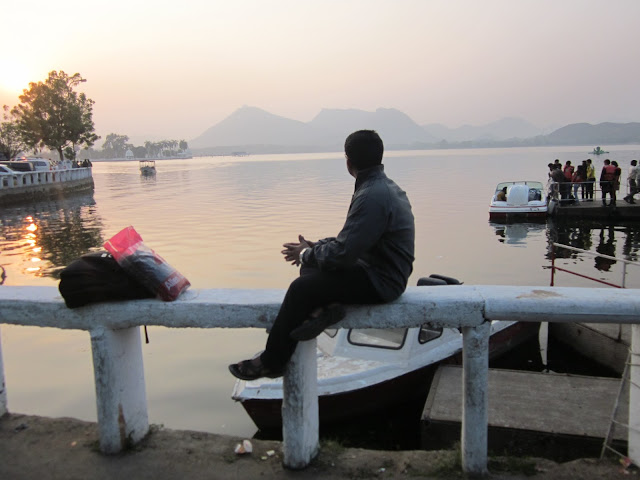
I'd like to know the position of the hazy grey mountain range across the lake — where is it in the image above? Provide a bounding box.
[189,106,640,155]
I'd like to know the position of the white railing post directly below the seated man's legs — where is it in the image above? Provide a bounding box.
[282,339,320,469]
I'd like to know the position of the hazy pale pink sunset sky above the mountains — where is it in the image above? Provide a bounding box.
[0,0,640,142]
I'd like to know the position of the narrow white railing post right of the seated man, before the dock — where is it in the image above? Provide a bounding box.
[461,322,491,475]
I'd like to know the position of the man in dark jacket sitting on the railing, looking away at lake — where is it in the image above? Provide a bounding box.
[229,130,415,380]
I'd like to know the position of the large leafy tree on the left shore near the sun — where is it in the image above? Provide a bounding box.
[11,70,100,160]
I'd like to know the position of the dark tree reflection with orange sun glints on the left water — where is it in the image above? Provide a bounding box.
[0,193,103,283]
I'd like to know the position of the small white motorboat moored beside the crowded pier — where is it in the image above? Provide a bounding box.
[489,180,547,220]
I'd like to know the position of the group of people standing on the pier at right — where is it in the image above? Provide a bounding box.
[548,158,640,205]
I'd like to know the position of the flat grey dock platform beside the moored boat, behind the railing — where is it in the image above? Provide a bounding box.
[421,365,628,461]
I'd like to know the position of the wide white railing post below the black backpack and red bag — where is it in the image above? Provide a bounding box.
[91,327,149,453]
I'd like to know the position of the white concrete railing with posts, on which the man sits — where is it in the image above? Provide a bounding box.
[0,285,640,474]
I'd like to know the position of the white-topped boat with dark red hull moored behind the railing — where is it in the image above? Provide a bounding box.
[232,310,538,431]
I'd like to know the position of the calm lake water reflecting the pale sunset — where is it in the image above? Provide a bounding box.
[0,145,640,436]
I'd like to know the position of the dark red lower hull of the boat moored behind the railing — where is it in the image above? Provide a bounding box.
[234,322,539,431]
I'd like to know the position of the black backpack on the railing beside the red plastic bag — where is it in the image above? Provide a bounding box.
[58,251,155,308]
